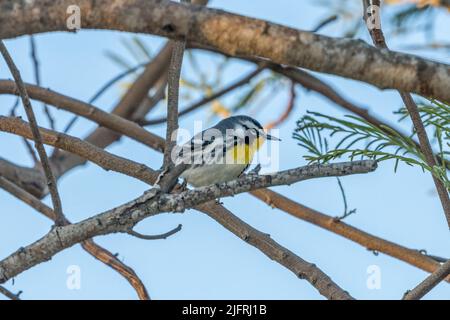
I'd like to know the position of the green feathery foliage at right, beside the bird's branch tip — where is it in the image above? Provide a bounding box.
[293,101,450,189]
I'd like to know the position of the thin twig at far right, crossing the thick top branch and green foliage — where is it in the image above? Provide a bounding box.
[363,0,450,228]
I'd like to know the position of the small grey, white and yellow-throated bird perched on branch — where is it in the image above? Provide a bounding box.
[174,115,281,187]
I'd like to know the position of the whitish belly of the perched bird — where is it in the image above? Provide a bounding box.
[181,164,247,187]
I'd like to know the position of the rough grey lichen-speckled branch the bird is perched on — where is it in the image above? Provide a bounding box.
[0,160,376,290]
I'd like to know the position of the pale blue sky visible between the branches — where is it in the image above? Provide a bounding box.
[0,0,450,299]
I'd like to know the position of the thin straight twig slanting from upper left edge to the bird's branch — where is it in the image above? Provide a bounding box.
[0,40,64,225]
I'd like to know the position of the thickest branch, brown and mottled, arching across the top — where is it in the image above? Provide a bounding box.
[0,0,450,102]
